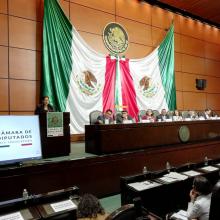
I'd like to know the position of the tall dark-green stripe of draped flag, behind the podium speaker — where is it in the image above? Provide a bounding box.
[41,0,72,111]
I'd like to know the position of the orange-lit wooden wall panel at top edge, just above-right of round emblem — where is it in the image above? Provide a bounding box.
[116,0,152,24]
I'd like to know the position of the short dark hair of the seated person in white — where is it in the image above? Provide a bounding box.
[193,176,212,195]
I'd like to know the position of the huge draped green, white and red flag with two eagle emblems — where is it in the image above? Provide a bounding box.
[41,0,176,134]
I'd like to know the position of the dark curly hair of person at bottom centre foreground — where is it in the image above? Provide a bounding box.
[77,194,105,218]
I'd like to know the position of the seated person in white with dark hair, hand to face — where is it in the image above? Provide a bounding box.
[187,176,212,220]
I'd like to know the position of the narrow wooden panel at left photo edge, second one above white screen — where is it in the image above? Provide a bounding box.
[0,46,8,78]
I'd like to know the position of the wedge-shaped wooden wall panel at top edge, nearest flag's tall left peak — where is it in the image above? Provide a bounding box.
[70,0,115,14]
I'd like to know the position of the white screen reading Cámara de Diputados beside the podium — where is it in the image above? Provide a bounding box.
[0,115,42,165]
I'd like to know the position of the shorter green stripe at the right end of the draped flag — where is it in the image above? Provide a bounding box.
[158,25,176,110]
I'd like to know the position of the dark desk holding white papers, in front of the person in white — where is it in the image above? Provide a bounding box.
[121,163,219,217]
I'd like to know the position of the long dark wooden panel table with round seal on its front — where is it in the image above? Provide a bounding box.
[85,120,220,155]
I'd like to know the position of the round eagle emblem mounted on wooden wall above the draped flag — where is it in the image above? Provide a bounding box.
[103,23,128,54]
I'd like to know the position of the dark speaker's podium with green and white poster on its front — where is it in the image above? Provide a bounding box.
[39,112,70,158]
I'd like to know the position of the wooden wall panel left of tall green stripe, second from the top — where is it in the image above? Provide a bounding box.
[9,16,37,50]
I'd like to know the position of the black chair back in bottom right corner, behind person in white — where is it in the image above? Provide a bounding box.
[209,180,220,220]
